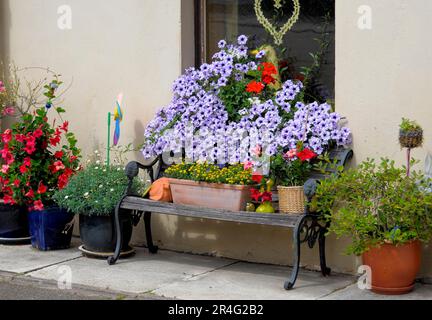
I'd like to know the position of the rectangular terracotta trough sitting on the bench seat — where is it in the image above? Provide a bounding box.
[170,179,251,211]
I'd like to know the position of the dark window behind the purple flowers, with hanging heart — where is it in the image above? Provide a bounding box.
[198,0,335,101]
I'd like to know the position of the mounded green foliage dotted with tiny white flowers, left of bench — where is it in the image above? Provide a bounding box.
[53,163,143,216]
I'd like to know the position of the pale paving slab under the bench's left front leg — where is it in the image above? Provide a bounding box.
[28,248,235,294]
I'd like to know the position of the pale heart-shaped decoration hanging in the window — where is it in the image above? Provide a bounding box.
[255,0,300,45]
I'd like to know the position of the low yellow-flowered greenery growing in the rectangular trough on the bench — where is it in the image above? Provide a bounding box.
[165,163,253,185]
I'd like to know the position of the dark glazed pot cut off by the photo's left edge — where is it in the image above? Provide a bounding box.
[0,203,30,244]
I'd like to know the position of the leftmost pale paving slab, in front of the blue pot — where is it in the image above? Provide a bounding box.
[0,240,82,273]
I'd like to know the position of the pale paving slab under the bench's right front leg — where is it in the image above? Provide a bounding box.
[154,262,355,300]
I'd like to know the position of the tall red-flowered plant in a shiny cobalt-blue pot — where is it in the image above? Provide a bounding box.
[0,76,80,250]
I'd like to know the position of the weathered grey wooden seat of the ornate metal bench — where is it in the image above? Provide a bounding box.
[121,196,302,227]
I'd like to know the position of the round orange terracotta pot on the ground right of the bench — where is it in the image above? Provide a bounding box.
[363,241,421,295]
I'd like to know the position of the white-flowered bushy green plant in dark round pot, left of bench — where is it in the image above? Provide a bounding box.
[54,161,142,257]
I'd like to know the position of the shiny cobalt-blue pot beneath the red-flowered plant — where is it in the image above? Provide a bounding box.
[28,206,74,251]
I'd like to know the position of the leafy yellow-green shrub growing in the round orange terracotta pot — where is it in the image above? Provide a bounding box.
[316,158,432,255]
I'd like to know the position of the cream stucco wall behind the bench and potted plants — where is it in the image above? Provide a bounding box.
[0,0,432,276]
